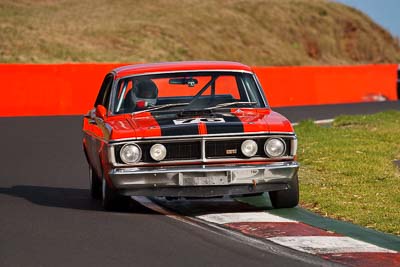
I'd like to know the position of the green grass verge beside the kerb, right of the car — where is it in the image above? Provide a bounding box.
[296,111,400,235]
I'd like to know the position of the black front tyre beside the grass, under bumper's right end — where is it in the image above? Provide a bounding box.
[269,174,299,209]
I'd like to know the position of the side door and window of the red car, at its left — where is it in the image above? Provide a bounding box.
[83,73,114,177]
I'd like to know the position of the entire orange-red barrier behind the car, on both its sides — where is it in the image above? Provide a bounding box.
[0,64,397,116]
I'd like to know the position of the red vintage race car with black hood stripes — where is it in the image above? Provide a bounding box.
[83,62,299,210]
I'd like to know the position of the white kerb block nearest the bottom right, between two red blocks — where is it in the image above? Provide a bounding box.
[268,236,397,254]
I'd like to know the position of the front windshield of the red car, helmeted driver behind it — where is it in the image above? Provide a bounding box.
[111,71,266,114]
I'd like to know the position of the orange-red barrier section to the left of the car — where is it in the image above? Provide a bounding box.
[0,64,126,116]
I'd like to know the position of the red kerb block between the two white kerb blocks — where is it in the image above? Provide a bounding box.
[225,222,340,238]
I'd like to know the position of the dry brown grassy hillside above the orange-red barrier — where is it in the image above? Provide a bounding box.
[0,0,400,65]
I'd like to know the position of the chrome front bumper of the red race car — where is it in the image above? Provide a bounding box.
[109,161,299,197]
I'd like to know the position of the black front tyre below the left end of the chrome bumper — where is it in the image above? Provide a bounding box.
[101,177,130,211]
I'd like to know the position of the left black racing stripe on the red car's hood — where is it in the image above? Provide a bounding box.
[152,113,199,136]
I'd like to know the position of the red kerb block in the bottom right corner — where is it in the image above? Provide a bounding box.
[321,252,400,267]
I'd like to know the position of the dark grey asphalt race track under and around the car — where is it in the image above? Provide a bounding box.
[0,102,399,267]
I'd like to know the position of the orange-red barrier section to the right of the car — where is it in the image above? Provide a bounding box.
[254,64,398,107]
